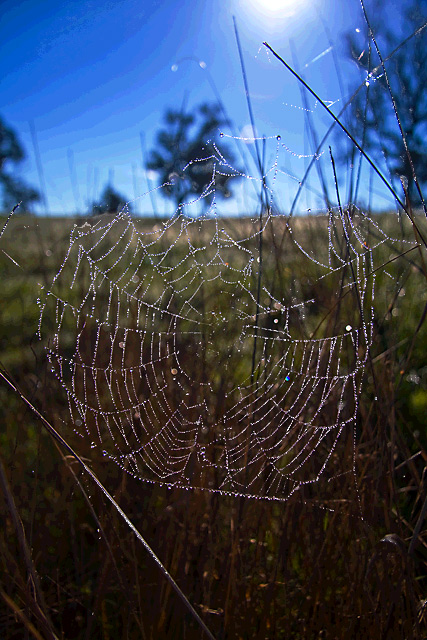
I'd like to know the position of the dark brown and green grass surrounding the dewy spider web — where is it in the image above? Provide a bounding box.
[0,208,427,640]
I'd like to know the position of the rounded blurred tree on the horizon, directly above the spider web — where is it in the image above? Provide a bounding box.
[146,104,239,207]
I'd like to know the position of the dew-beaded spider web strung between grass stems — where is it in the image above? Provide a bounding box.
[36,136,414,500]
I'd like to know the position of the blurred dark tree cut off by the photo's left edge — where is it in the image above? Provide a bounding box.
[0,118,40,211]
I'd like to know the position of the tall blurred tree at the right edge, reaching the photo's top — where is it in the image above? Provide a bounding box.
[345,0,427,202]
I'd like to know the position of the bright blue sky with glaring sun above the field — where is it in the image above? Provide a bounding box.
[0,0,402,214]
